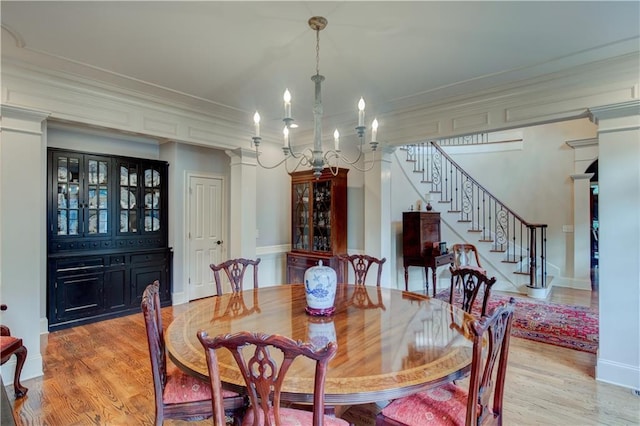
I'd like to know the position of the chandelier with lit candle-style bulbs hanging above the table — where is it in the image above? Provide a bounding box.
[252,16,378,178]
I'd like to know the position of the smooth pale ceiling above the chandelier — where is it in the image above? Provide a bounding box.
[0,0,640,135]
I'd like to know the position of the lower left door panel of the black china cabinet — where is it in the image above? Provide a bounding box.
[56,272,104,320]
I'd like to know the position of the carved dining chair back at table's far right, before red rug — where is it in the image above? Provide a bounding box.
[449,267,496,316]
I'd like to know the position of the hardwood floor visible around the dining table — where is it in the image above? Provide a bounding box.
[2,288,640,426]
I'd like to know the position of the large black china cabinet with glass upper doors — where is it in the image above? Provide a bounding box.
[47,149,172,331]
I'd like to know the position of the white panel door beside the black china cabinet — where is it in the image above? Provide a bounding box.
[188,176,225,300]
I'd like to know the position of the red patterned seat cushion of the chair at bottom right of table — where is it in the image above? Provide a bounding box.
[381,383,468,426]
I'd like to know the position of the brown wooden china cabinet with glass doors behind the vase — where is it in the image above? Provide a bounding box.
[287,168,349,283]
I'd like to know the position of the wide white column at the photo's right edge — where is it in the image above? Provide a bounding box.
[591,100,640,389]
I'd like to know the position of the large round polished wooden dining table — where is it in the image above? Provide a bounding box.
[165,284,473,405]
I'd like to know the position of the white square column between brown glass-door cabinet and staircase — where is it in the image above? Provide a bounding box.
[363,147,397,288]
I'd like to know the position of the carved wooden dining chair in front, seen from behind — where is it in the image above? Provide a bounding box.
[198,330,349,426]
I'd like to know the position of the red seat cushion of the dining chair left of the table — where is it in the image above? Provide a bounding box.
[162,365,238,404]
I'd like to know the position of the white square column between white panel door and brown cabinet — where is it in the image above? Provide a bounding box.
[226,148,258,259]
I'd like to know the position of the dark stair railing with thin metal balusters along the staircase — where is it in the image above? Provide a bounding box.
[405,141,547,288]
